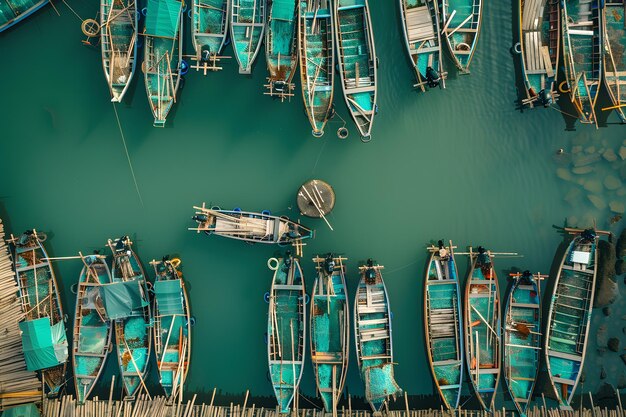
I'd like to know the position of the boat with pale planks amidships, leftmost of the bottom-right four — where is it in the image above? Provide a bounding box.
[424,240,464,410]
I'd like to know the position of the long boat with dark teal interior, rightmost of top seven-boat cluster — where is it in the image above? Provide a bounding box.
[334,0,378,139]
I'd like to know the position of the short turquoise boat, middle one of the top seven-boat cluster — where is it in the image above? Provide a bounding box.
[230,0,266,74]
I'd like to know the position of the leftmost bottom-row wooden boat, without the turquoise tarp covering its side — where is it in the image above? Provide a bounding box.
[9,230,69,395]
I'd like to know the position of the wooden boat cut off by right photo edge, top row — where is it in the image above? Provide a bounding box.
[602,0,626,123]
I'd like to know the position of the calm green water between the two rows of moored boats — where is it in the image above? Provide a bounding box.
[0,0,626,406]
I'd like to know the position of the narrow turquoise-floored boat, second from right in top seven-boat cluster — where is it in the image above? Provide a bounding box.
[298,0,335,137]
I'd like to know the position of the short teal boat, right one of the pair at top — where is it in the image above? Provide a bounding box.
[441,0,483,74]
